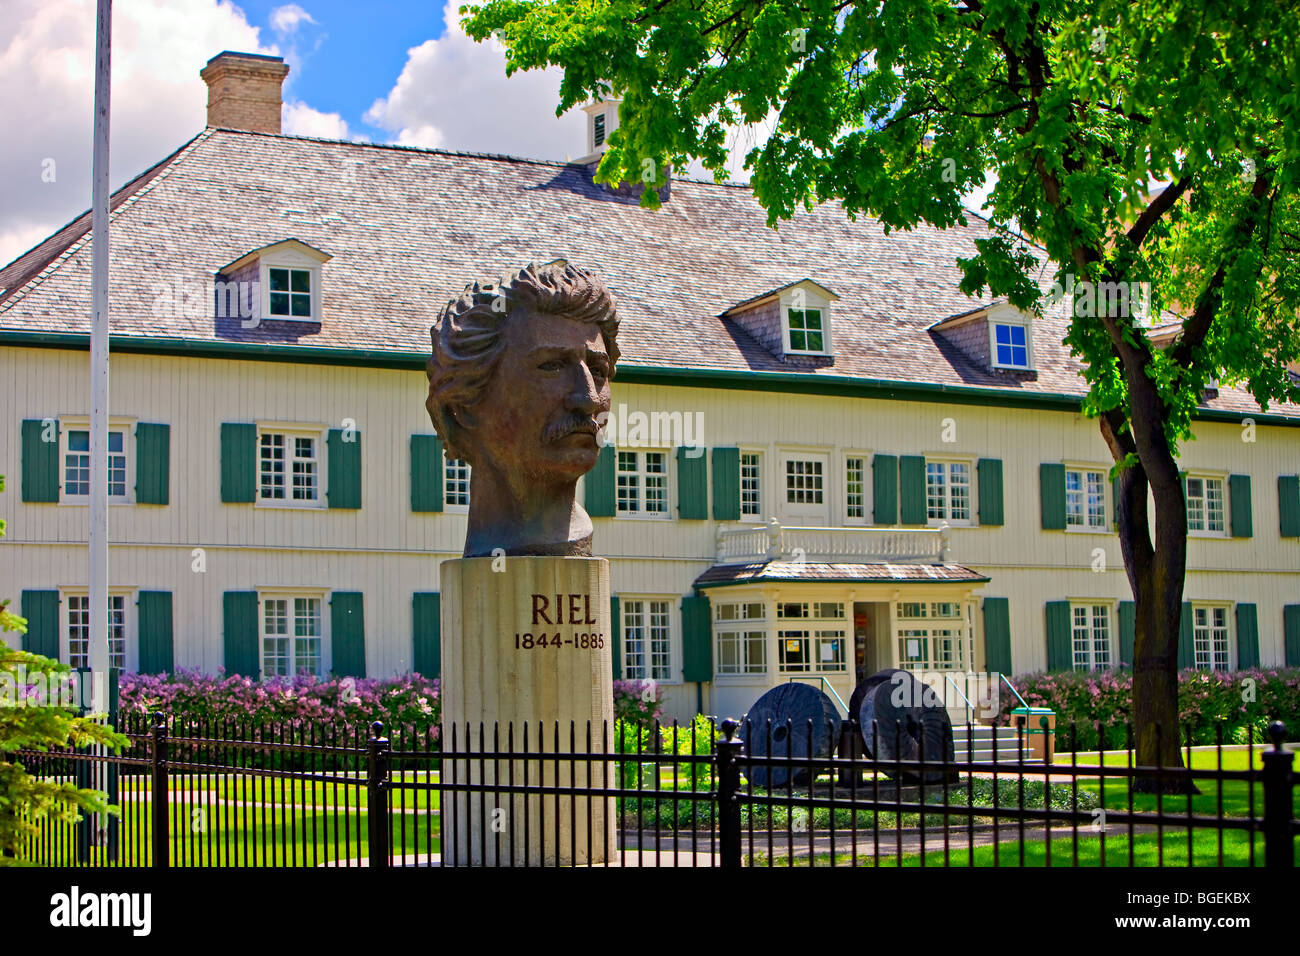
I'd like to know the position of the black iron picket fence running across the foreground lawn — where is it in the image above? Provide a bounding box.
[17,714,1297,868]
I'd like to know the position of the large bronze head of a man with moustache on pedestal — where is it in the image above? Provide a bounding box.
[425,260,619,558]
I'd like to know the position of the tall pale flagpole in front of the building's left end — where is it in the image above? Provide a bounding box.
[88,0,111,713]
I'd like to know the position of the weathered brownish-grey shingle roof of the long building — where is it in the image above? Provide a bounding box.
[0,129,1300,415]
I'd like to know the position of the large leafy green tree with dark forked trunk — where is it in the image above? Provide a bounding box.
[463,0,1300,780]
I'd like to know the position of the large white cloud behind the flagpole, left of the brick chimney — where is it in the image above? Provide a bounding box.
[0,0,277,264]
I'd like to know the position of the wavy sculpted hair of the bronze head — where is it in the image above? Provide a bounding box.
[425,263,619,464]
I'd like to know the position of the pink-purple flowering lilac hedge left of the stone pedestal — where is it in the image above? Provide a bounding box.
[120,670,442,740]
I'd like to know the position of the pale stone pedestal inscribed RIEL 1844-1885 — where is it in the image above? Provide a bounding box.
[442,557,618,866]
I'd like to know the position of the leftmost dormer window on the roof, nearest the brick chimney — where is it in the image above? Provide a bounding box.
[216,239,332,328]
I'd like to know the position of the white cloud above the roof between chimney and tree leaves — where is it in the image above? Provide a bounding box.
[364,0,586,160]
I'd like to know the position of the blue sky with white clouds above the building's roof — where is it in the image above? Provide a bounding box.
[0,0,987,264]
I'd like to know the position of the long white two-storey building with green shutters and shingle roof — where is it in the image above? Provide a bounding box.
[0,55,1300,718]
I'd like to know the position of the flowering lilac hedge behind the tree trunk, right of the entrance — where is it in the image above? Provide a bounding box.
[1000,667,1300,750]
